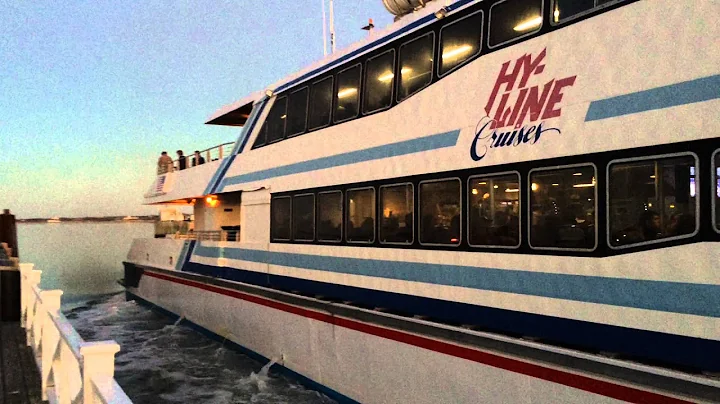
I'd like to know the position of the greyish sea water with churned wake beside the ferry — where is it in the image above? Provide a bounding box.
[18,223,334,404]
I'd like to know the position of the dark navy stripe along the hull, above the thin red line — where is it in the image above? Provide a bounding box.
[132,262,720,372]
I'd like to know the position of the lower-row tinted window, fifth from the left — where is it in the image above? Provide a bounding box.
[380,184,415,244]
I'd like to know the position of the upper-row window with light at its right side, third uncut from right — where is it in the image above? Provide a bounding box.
[363,50,395,113]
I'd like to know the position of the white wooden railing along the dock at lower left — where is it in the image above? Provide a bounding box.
[20,264,132,404]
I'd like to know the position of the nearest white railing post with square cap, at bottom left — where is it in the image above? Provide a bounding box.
[80,340,120,404]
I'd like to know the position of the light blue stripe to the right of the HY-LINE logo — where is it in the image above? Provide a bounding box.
[585,75,720,122]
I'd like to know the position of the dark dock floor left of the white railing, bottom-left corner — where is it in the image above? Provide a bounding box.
[0,322,43,404]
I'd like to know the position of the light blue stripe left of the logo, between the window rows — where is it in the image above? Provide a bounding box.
[220,129,460,191]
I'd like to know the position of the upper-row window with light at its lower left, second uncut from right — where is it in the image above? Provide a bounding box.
[398,33,435,101]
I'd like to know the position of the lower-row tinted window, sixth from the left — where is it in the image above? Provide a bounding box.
[420,179,462,245]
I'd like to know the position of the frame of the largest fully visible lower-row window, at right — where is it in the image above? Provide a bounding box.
[605,151,700,251]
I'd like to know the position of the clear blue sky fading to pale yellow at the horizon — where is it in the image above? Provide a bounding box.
[0,0,392,218]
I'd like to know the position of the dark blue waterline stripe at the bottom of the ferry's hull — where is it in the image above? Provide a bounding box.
[125,291,359,404]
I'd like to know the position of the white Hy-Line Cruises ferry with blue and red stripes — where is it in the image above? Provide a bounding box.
[124,0,720,403]
